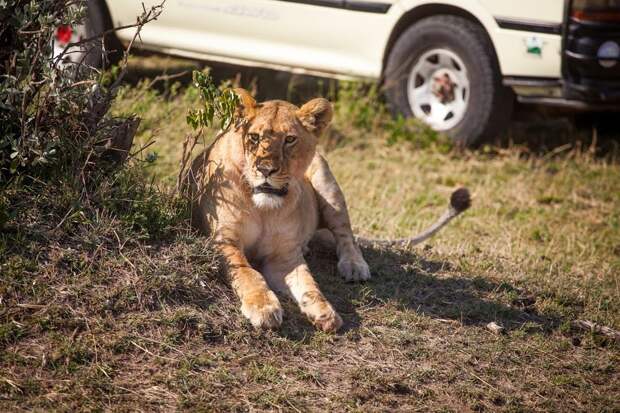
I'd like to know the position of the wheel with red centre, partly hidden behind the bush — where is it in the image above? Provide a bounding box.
[54,0,124,69]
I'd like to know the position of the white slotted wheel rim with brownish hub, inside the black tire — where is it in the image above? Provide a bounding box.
[407,49,469,131]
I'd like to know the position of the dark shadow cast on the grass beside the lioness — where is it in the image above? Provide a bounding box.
[285,241,561,338]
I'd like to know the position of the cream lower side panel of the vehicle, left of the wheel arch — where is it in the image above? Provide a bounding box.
[108,0,399,78]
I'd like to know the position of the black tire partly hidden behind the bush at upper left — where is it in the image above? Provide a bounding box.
[84,0,124,69]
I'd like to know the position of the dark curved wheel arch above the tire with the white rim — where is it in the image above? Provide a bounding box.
[381,2,500,81]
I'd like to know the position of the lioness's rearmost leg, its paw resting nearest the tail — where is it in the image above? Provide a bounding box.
[309,154,370,281]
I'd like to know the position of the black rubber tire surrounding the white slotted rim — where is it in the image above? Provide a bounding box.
[384,15,514,146]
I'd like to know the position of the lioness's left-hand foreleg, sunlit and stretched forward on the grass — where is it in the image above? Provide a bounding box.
[219,243,282,328]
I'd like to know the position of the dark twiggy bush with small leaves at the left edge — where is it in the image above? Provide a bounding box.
[0,0,160,183]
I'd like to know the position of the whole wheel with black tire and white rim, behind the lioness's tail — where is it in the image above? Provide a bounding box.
[384,15,514,146]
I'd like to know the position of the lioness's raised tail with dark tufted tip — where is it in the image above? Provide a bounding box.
[356,188,471,247]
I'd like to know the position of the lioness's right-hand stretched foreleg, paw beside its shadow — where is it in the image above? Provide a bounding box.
[263,252,342,331]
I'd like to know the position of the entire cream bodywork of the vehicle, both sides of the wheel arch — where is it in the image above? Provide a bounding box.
[107,0,564,79]
